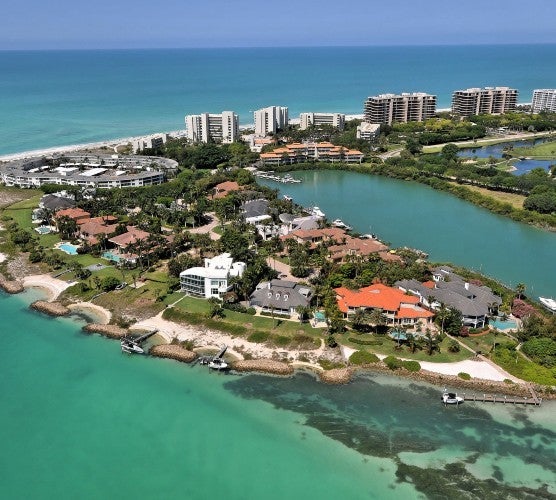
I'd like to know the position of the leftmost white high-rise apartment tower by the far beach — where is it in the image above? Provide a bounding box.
[185,111,239,143]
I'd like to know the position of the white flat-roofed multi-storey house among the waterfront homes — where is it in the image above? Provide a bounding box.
[180,253,245,299]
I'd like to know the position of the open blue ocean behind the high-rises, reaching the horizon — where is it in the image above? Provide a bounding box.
[0,45,556,155]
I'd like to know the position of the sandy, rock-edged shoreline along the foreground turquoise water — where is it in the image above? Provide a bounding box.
[3,275,556,400]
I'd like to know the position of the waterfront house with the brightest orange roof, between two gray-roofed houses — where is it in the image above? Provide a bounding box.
[334,283,434,326]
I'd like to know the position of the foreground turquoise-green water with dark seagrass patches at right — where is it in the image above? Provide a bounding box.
[0,292,556,500]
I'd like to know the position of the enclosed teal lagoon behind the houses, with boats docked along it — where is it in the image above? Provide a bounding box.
[259,170,556,298]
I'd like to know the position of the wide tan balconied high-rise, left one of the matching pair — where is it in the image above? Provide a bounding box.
[364,92,436,125]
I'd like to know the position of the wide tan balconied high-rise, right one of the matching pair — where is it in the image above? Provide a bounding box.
[452,87,518,116]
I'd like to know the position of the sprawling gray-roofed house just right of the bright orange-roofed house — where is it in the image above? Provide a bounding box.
[396,266,502,328]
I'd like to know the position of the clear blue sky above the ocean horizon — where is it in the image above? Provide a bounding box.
[0,0,556,50]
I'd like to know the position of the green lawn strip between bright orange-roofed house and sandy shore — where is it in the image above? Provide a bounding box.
[346,333,473,363]
